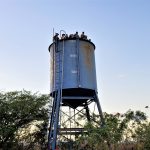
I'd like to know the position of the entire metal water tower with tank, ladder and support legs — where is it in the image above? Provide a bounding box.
[48,30,102,150]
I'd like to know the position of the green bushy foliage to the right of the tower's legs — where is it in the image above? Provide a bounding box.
[78,110,150,150]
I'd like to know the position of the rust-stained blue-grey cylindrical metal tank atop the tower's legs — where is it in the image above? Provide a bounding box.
[49,32,97,96]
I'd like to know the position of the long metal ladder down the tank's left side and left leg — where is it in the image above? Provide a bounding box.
[48,40,63,150]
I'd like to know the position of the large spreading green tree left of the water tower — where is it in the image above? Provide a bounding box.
[0,90,49,149]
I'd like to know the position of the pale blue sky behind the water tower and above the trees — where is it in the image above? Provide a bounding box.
[0,0,150,116]
